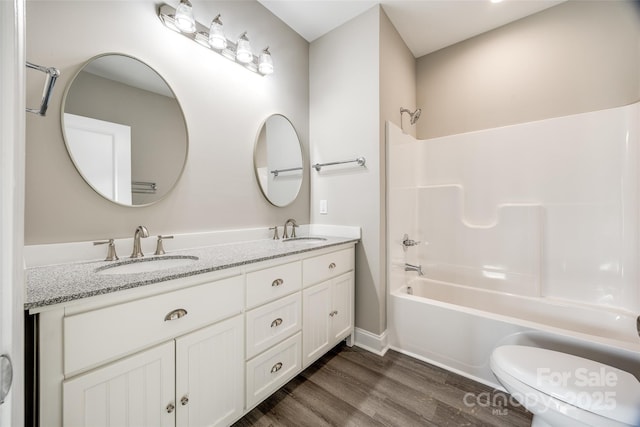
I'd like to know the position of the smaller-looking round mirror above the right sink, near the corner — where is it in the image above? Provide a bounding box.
[253,114,304,207]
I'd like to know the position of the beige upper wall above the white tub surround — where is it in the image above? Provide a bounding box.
[417,1,640,139]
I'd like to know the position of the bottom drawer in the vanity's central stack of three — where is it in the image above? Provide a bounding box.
[247,333,302,409]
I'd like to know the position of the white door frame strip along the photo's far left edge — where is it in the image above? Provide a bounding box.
[0,0,26,427]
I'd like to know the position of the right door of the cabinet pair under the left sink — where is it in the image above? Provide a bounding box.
[176,316,244,426]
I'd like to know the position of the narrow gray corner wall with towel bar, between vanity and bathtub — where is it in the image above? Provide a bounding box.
[310,6,415,334]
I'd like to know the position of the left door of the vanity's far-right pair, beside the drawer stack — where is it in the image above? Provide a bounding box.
[302,282,332,368]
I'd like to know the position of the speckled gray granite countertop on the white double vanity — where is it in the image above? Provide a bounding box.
[24,236,359,310]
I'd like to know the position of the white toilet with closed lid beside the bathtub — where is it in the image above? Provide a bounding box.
[491,345,640,427]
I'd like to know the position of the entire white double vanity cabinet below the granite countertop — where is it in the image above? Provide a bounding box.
[32,243,354,427]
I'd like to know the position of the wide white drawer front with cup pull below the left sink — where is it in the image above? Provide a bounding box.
[63,276,244,375]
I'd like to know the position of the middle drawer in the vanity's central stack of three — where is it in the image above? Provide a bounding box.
[247,292,302,359]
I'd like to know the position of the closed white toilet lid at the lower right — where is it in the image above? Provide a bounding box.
[491,345,640,426]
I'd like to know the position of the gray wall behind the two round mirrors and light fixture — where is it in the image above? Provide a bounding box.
[25,0,309,244]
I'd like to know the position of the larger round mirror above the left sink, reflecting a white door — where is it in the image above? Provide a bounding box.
[62,54,188,206]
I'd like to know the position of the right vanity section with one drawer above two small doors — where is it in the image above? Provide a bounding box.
[302,249,354,368]
